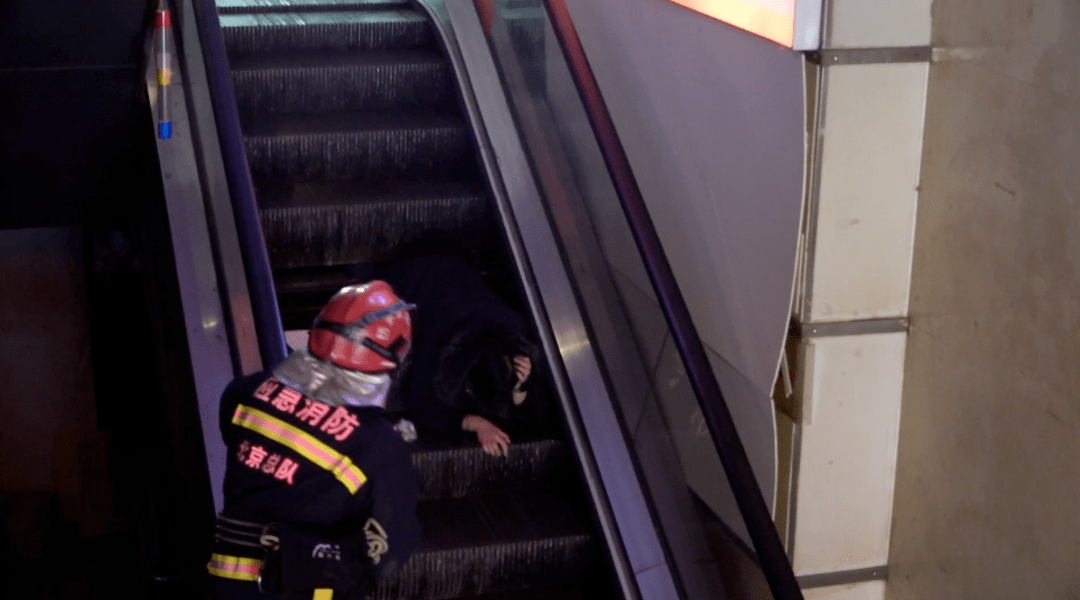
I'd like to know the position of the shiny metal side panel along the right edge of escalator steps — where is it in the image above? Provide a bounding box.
[429,2,678,598]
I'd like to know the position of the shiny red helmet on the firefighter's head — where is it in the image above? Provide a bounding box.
[308,281,415,373]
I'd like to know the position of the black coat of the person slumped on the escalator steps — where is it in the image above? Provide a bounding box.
[353,255,539,434]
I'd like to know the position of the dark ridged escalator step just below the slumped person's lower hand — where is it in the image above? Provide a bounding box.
[413,439,573,501]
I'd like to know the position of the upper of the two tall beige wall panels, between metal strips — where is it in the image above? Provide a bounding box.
[807,63,927,322]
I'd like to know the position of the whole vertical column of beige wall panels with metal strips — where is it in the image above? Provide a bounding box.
[786,0,930,600]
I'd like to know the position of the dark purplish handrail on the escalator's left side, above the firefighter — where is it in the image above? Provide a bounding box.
[192,0,285,367]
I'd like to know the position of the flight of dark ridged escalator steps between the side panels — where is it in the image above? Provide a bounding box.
[217,0,616,600]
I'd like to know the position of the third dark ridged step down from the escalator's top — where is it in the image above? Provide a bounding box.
[243,112,475,181]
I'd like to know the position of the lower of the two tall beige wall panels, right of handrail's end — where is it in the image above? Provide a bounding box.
[793,332,906,575]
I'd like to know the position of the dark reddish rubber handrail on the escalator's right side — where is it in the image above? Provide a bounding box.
[543,0,802,600]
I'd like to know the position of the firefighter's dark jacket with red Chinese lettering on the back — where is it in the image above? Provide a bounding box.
[210,371,419,598]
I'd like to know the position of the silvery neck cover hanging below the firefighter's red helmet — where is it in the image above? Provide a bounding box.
[273,347,391,409]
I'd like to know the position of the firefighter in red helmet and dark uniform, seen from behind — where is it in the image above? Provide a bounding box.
[207,281,419,600]
